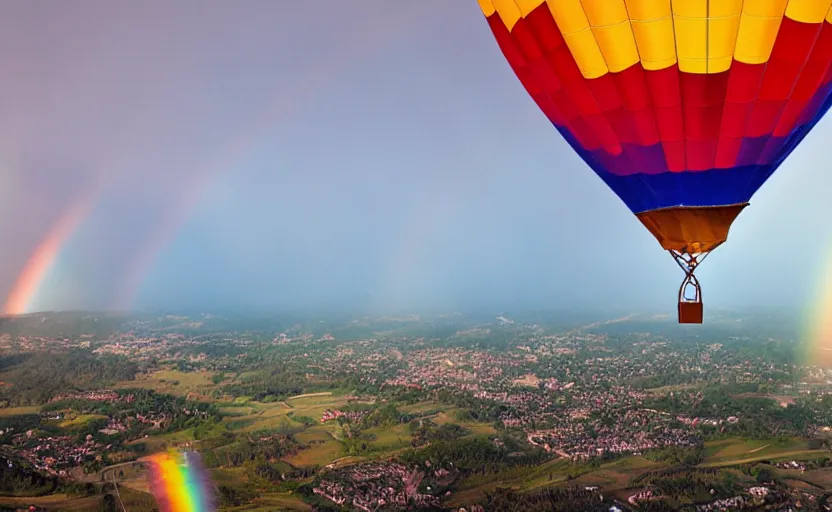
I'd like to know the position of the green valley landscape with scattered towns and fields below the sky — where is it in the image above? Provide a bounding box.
[0,313,832,512]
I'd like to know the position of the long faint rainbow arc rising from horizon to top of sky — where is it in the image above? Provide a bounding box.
[116,3,432,310]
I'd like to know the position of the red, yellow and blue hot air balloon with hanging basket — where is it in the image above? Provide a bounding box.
[478,0,832,323]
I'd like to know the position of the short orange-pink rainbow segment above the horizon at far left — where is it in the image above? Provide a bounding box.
[1,187,98,315]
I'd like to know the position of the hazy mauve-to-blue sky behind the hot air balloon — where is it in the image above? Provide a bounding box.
[0,0,832,314]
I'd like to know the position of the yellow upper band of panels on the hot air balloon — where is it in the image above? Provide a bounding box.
[477,0,832,78]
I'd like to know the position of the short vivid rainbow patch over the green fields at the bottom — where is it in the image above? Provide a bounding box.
[148,452,216,512]
